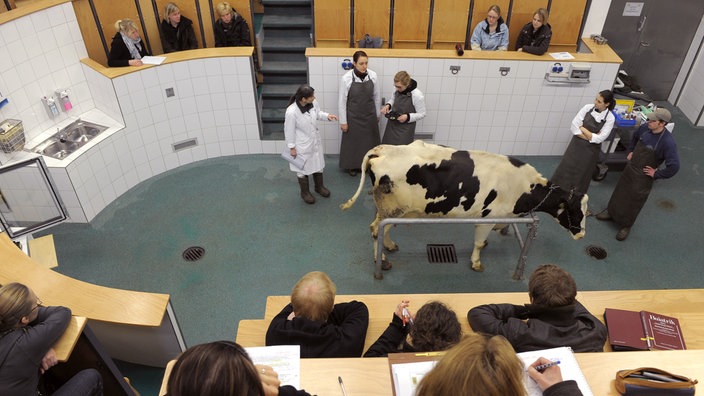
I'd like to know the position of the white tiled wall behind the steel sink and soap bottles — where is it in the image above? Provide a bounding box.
[0,3,94,163]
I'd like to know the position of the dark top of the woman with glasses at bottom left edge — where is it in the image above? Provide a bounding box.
[0,307,71,396]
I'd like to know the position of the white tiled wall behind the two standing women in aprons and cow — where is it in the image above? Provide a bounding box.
[308,57,618,155]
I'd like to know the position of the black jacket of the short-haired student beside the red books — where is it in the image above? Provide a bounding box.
[467,302,606,352]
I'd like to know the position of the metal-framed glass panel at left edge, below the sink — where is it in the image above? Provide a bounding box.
[0,157,66,238]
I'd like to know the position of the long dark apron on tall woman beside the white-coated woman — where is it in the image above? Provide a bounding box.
[340,80,381,169]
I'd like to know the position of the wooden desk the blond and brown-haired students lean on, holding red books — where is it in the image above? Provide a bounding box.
[260,289,704,350]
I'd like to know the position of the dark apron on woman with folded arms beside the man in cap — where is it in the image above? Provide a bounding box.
[550,109,608,194]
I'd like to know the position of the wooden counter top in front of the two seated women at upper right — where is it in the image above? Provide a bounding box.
[306,37,623,63]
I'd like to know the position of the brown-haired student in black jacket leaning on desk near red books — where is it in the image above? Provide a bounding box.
[467,264,606,352]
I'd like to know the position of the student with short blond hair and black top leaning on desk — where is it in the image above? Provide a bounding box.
[266,271,369,358]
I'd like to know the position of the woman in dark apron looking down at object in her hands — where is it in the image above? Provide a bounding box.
[381,71,425,144]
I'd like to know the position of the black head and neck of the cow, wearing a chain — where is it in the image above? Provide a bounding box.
[514,182,589,239]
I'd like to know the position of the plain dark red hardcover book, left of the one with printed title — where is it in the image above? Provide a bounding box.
[604,308,648,351]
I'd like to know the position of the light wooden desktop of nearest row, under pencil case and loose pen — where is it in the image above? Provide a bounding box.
[294,350,704,396]
